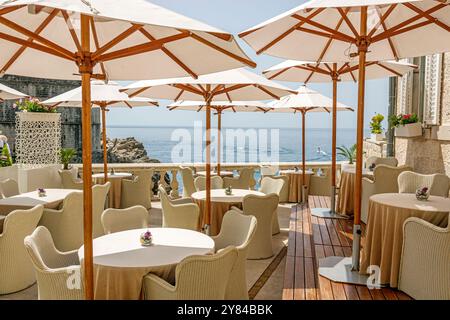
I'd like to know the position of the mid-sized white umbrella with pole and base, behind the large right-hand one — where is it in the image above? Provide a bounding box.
[264,60,417,219]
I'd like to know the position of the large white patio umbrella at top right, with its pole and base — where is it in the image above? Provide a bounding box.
[239,0,450,283]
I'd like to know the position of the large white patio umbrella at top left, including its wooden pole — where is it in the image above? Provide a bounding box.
[0,0,255,299]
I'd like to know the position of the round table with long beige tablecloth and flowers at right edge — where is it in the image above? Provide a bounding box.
[361,193,450,288]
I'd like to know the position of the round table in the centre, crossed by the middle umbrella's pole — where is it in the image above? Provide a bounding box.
[191,189,265,236]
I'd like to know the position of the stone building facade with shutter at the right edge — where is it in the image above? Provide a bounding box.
[394,53,450,176]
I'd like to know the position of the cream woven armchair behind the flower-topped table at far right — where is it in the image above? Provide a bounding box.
[398,172,450,198]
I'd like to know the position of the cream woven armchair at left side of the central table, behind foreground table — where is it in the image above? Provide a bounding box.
[159,186,200,231]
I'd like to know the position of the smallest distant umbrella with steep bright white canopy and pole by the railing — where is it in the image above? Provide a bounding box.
[268,86,354,202]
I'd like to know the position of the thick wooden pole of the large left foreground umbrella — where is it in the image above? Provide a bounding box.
[79,15,94,300]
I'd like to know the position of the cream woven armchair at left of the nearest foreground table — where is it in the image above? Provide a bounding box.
[24,227,84,300]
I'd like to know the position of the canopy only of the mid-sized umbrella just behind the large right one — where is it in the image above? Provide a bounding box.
[264,60,417,83]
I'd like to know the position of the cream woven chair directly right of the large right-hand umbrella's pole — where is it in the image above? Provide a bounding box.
[373,164,412,194]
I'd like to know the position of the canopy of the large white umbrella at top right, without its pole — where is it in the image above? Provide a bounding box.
[239,0,450,62]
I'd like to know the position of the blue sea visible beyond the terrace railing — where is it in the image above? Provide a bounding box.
[107,127,369,163]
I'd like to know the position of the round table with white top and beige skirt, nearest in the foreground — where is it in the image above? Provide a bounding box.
[78,228,214,300]
